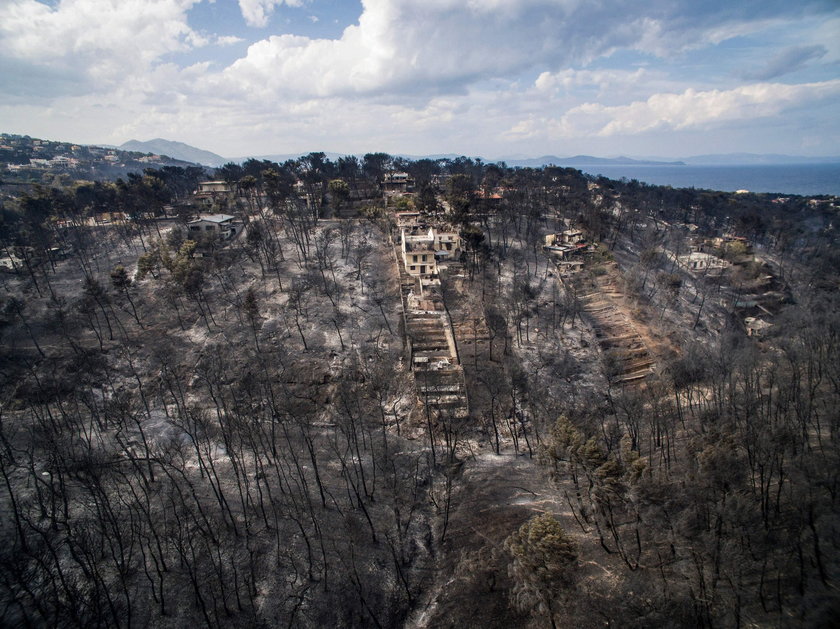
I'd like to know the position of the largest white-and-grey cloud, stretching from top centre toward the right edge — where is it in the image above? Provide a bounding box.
[215,0,832,102]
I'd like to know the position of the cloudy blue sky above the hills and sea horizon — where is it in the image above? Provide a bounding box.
[0,0,840,159]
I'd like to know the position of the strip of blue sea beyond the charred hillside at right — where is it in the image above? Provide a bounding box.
[574,164,840,196]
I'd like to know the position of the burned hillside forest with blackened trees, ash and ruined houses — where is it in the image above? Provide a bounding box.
[0,153,840,629]
